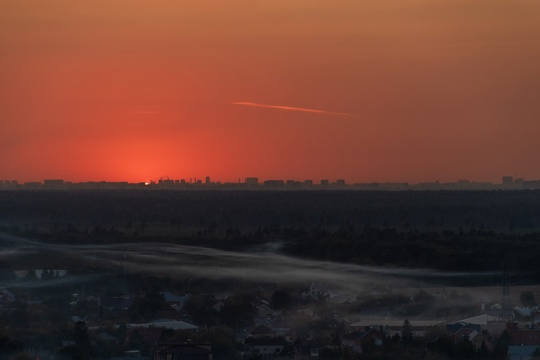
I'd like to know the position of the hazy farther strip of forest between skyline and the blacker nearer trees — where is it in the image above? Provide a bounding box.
[0,190,540,232]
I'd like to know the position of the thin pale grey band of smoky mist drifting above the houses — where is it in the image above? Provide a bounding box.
[0,234,501,293]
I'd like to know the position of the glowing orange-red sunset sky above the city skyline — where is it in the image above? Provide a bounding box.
[0,0,540,182]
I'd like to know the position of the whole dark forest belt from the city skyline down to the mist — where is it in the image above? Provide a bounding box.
[0,191,540,280]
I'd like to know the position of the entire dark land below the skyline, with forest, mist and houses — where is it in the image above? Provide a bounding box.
[0,190,540,360]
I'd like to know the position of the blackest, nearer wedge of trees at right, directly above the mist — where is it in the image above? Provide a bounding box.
[283,228,540,281]
